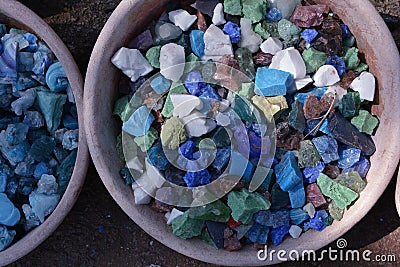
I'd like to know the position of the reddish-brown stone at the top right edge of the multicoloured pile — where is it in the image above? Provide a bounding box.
[290,5,327,28]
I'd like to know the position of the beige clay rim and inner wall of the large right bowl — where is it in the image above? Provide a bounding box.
[84,0,400,266]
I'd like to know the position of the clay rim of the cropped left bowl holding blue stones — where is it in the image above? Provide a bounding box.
[0,0,90,266]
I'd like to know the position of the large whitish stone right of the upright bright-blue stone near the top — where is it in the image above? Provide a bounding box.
[202,24,233,61]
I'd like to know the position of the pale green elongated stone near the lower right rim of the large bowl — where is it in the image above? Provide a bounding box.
[317,174,358,209]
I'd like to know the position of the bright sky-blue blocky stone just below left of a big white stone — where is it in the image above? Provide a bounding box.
[254,67,294,96]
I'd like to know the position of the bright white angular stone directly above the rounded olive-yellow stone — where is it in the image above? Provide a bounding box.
[170,94,203,118]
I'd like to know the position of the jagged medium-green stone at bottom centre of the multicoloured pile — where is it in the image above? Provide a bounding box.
[228,188,271,224]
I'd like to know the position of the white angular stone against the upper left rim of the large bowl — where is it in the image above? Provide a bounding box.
[111,47,153,82]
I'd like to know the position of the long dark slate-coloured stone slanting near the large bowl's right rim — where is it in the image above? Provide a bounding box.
[329,112,376,156]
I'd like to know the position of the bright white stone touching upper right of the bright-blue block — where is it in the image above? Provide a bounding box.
[269,47,306,79]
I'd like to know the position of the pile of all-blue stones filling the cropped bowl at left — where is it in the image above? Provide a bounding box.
[0,25,78,251]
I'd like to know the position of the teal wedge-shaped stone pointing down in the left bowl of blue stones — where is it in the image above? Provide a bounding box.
[36,91,67,134]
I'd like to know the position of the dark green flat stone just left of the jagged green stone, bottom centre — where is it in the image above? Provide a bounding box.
[186,200,231,222]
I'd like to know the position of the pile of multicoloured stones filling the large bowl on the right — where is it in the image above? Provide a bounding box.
[112,0,378,251]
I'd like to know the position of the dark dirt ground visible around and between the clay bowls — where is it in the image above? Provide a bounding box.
[8,0,400,267]
